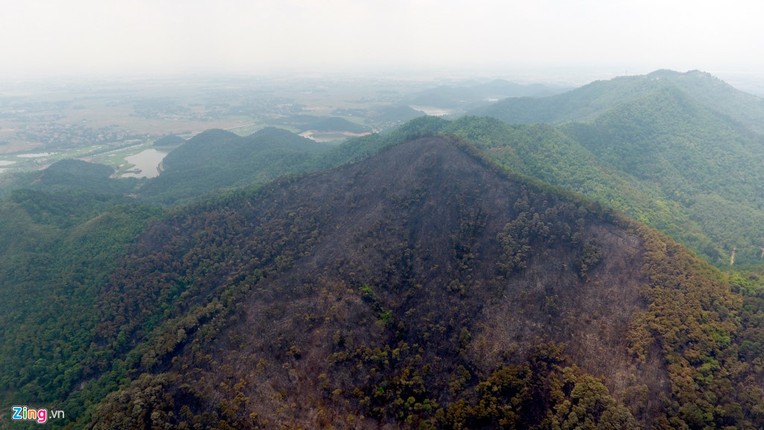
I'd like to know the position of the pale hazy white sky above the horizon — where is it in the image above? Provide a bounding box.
[0,0,764,78]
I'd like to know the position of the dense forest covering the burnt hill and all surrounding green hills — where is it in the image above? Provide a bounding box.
[0,72,764,429]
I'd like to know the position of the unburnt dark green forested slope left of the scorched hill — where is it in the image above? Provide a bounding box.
[0,189,160,420]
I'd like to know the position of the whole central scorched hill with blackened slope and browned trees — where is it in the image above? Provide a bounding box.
[76,138,764,428]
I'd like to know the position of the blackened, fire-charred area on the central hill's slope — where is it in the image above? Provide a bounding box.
[88,137,666,428]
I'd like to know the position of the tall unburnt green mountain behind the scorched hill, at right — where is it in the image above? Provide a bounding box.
[460,71,764,264]
